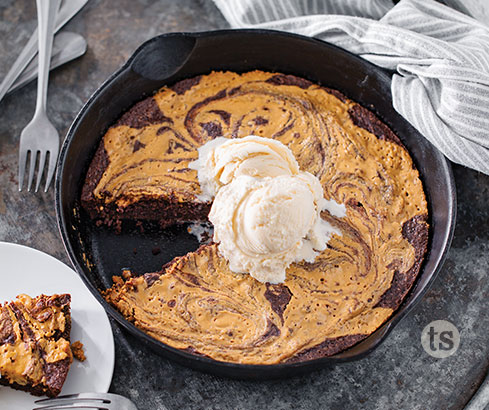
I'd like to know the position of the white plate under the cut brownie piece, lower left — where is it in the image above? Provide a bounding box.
[0,242,114,410]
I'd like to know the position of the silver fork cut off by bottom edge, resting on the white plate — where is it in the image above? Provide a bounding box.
[33,393,138,410]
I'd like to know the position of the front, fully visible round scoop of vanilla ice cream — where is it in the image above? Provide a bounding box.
[209,171,340,283]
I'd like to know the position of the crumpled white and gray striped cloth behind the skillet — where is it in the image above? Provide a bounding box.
[214,0,489,174]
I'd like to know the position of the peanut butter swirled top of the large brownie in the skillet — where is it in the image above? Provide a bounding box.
[99,71,428,364]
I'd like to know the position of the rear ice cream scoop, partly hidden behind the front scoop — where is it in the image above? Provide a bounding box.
[189,135,299,201]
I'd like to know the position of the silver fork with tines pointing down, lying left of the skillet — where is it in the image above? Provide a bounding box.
[19,0,61,192]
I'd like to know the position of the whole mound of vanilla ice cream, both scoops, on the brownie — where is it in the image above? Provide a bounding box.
[190,135,346,283]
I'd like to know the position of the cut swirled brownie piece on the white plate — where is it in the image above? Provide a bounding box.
[0,294,73,397]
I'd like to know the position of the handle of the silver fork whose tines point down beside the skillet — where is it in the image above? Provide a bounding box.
[34,0,61,117]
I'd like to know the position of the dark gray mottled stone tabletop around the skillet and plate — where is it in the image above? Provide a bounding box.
[0,0,489,410]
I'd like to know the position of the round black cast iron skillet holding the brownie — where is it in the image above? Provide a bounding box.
[56,30,456,379]
